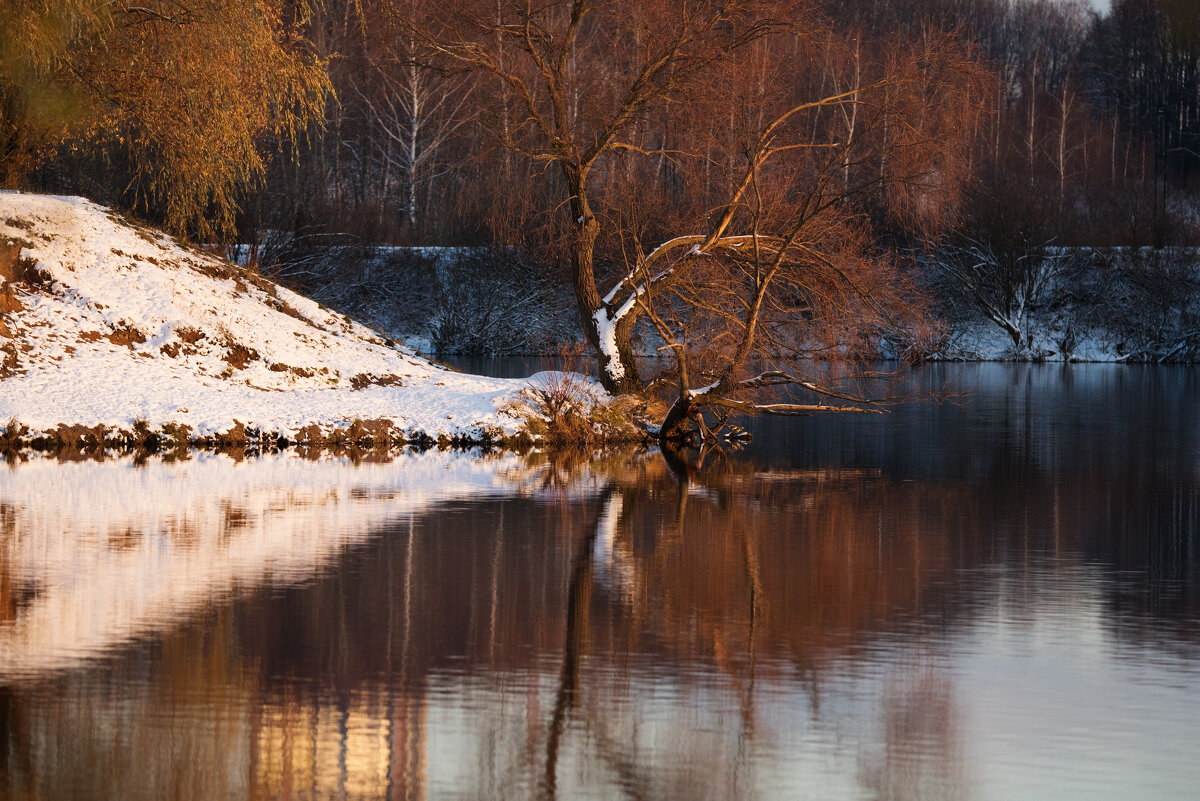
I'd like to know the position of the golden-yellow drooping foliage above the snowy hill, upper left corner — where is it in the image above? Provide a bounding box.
[0,0,329,239]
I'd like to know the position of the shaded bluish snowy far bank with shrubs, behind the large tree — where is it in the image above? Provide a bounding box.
[232,231,1200,362]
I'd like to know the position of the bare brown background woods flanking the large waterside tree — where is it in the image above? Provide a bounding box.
[213,0,1200,250]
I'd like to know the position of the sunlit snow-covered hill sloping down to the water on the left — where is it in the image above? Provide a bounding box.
[0,192,526,438]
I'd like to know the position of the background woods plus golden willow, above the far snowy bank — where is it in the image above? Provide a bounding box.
[7,0,1200,245]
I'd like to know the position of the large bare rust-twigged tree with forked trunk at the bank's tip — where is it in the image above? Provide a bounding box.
[397,0,984,438]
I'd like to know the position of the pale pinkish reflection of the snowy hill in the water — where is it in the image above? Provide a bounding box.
[0,451,540,681]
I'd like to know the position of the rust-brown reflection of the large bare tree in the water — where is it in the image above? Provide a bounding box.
[542,455,965,799]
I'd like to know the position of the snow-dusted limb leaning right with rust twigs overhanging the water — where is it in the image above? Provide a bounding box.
[606,31,985,438]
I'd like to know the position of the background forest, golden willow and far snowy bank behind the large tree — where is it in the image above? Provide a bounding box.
[0,0,1200,360]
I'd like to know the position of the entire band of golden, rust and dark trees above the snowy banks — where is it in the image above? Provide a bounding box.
[0,0,1200,438]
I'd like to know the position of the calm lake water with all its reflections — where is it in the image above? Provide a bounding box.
[0,365,1200,800]
